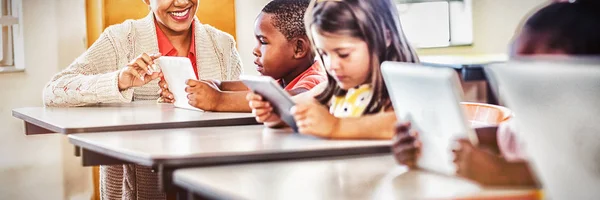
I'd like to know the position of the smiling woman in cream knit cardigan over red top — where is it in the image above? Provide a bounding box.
[43,0,241,199]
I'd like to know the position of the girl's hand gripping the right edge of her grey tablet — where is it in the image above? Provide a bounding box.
[291,100,340,138]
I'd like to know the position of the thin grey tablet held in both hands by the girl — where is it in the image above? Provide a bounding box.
[240,75,298,132]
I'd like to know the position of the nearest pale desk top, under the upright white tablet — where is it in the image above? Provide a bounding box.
[174,155,537,200]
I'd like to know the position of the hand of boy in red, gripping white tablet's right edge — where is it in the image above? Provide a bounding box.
[185,79,221,111]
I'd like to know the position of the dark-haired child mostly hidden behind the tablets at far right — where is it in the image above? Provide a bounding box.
[392,0,600,186]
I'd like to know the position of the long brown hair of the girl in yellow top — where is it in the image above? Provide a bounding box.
[305,0,419,114]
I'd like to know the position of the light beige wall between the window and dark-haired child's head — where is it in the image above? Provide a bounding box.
[418,0,548,55]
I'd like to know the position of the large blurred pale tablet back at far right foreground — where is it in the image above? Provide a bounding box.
[486,57,600,199]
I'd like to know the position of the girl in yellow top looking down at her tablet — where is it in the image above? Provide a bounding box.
[248,0,418,139]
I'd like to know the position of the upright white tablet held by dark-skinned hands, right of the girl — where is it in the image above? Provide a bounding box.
[381,62,477,175]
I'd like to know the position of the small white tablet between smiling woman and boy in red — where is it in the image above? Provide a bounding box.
[154,56,202,111]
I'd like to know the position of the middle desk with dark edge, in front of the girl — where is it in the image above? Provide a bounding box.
[69,125,391,190]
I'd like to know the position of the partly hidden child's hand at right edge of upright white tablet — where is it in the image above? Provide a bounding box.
[452,139,510,185]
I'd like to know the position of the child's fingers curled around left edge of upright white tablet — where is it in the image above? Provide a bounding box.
[392,122,421,169]
